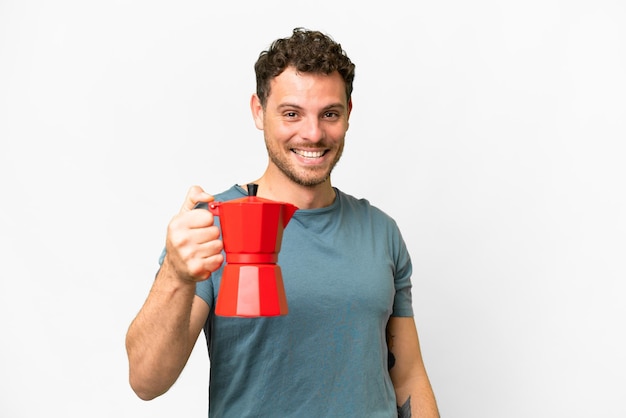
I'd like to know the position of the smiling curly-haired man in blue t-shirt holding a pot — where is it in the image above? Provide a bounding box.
[126,29,439,418]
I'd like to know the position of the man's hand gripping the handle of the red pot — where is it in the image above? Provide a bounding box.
[163,186,224,282]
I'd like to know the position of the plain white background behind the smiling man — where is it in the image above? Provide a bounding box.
[0,0,626,418]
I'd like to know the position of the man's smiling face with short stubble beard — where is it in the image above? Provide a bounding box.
[253,67,351,187]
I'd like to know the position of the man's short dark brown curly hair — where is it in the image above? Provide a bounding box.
[254,28,355,107]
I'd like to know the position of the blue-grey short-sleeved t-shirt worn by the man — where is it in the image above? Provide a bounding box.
[174,186,413,418]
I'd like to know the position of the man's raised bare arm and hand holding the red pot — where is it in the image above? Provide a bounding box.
[126,186,224,400]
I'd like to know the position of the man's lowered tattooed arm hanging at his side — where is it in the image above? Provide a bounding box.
[387,317,439,418]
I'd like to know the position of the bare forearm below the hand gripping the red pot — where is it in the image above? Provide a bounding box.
[126,261,197,400]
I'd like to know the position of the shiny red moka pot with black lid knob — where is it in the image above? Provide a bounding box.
[209,184,298,317]
